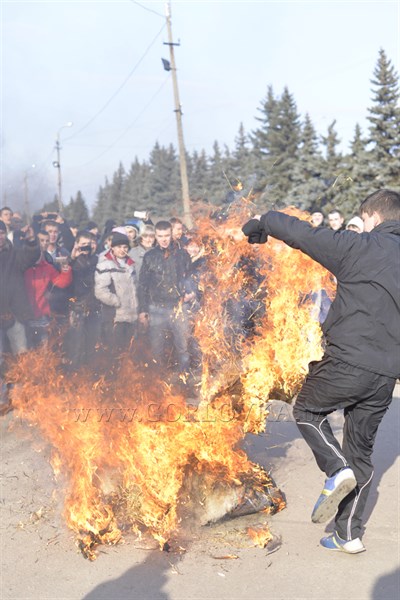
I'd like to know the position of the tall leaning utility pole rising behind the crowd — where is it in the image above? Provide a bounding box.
[164,2,193,228]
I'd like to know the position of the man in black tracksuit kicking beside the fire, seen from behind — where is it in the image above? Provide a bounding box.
[243,190,400,554]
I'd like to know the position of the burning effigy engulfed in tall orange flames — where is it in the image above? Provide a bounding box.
[8,199,334,560]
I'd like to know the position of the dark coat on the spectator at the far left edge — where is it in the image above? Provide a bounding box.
[0,240,40,326]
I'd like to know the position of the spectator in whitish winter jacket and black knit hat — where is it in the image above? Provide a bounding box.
[94,232,137,352]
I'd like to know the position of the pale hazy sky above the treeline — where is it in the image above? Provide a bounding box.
[1,0,400,209]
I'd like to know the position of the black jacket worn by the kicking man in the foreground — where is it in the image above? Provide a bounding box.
[260,211,400,378]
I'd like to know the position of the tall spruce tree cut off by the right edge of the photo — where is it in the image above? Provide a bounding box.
[367,49,400,193]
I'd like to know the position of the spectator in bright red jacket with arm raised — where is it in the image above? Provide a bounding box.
[24,231,72,348]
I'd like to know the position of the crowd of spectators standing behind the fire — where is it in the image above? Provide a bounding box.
[0,206,372,412]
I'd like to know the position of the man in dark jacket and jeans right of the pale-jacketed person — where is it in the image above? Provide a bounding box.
[138,221,195,373]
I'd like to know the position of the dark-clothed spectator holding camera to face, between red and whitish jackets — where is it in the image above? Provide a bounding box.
[64,231,101,370]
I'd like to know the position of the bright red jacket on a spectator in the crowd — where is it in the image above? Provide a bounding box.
[24,258,72,319]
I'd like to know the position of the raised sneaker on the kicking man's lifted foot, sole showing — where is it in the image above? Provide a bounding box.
[311,467,357,523]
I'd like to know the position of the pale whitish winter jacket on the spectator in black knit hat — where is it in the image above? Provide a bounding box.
[94,250,138,323]
